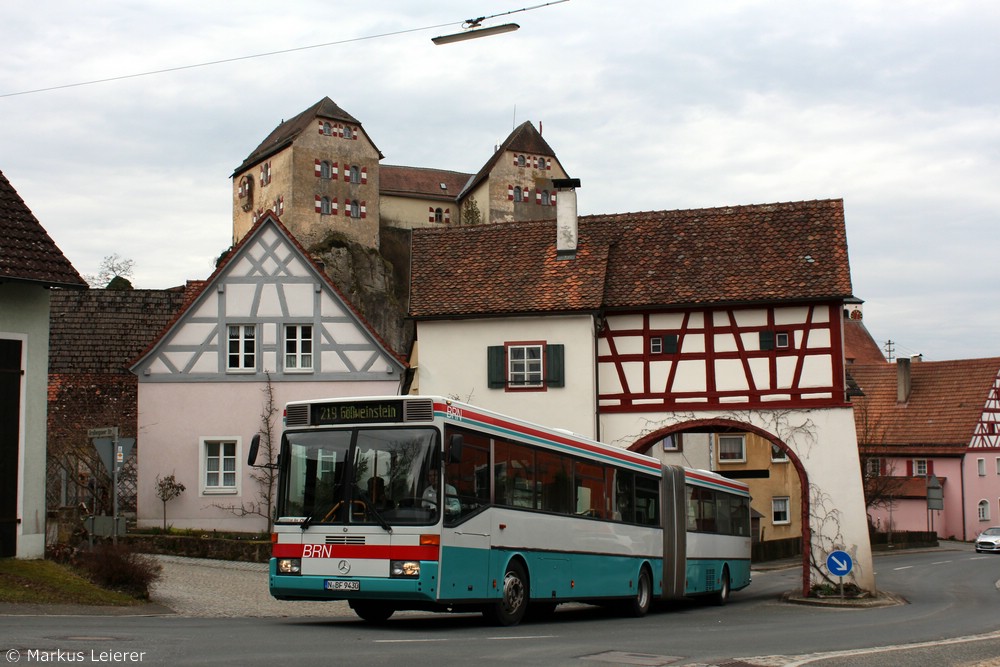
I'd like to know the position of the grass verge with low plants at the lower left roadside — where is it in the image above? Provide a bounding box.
[0,558,145,607]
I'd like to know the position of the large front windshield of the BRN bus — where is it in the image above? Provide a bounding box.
[278,428,441,528]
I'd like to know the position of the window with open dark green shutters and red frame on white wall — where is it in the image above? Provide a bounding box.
[486,342,566,390]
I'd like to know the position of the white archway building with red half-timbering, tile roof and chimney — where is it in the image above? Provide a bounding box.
[410,194,874,588]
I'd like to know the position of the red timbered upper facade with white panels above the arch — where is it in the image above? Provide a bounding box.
[597,302,845,413]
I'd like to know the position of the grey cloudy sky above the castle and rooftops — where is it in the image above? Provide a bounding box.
[0,0,1000,360]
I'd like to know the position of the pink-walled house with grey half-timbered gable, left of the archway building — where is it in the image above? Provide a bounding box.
[132,212,405,531]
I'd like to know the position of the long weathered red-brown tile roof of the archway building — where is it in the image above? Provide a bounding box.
[410,200,851,318]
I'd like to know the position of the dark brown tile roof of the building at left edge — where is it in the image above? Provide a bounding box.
[0,172,87,288]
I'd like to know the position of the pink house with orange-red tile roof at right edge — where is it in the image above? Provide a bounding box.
[850,357,1000,540]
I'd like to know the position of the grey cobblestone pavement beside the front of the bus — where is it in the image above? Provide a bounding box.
[150,556,354,617]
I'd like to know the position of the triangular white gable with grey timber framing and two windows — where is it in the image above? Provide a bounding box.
[134,217,403,382]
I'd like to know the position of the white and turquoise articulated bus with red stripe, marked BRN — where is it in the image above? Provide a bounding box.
[249,396,750,625]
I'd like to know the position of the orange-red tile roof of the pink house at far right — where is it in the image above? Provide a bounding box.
[848,357,1000,454]
